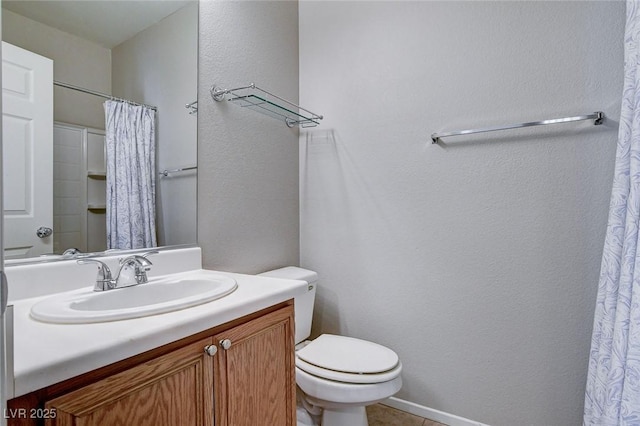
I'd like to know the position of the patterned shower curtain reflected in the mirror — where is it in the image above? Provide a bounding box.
[104,100,157,249]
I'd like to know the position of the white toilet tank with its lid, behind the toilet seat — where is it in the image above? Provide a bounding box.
[258,266,318,345]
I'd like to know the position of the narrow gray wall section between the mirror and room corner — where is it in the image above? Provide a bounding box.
[198,1,299,273]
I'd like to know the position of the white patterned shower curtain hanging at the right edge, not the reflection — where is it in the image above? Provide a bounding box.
[584,1,640,426]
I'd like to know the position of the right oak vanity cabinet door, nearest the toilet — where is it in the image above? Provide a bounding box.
[213,306,296,426]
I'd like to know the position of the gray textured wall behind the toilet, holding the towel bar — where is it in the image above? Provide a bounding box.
[299,1,625,426]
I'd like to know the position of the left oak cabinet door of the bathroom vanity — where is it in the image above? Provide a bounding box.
[45,338,213,426]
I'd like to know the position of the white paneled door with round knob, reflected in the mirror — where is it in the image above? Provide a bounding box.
[2,42,53,259]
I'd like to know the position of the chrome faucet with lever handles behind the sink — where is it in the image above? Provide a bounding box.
[77,250,158,291]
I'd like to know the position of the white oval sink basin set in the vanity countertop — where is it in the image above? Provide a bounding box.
[31,270,238,324]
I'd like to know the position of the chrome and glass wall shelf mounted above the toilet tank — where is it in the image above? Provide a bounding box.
[210,83,322,127]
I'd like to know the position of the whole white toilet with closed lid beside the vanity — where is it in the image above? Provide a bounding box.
[260,266,402,426]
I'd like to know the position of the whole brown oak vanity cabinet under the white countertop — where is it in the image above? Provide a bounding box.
[8,301,296,426]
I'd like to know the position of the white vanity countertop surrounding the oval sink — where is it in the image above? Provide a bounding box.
[10,272,307,398]
